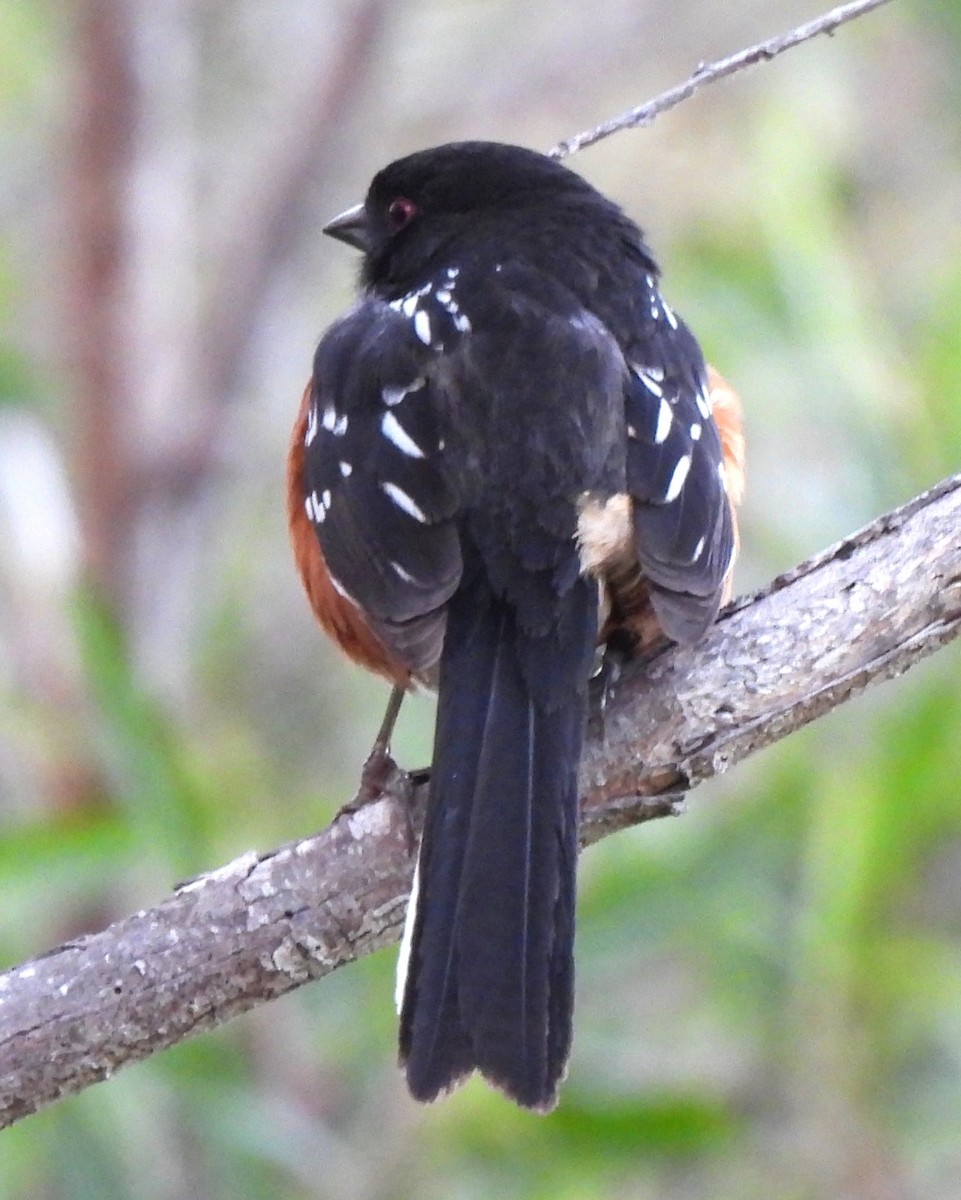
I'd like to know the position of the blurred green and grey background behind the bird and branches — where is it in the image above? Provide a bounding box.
[0,0,961,1200]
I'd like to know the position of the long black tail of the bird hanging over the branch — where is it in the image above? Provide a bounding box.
[398,568,596,1110]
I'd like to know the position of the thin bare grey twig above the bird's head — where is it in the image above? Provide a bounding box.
[548,0,888,158]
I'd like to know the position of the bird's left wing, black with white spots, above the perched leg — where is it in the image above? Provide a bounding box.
[302,298,461,676]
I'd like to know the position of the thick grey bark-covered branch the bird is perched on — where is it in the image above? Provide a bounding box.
[0,475,961,1127]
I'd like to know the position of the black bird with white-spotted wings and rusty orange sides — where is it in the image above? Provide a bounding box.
[287,142,744,1112]
